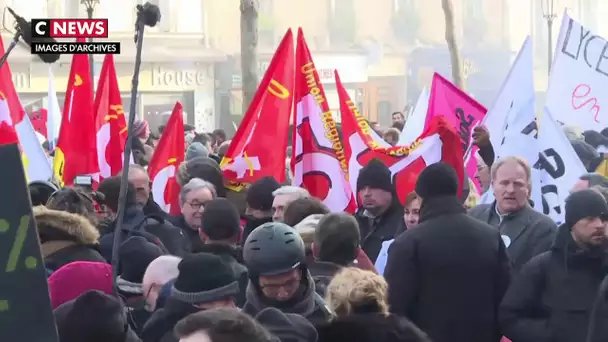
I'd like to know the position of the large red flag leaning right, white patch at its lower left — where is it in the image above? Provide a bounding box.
[221,30,294,191]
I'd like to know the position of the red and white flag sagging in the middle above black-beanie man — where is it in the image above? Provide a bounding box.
[335,71,464,203]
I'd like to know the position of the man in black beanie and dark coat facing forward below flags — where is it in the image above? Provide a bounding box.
[355,159,406,263]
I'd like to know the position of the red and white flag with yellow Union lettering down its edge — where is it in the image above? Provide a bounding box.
[291,29,356,213]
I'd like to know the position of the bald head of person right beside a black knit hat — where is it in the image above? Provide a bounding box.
[142,255,182,311]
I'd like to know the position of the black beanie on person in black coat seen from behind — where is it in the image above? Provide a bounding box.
[416,162,458,199]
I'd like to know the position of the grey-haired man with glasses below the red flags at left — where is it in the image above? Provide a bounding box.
[172,178,217,251]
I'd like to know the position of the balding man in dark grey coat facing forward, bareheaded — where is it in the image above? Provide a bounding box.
[469,157,557,271]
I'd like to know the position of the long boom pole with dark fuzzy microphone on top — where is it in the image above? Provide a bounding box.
[112,2,161,294]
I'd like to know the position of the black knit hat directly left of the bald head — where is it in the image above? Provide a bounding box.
[116,236,164,294]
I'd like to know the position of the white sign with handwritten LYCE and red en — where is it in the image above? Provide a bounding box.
[546,13,608,131]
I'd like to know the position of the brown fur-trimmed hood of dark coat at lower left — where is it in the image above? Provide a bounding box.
[34,206,105,271]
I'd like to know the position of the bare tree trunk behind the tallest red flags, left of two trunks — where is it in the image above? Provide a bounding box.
[240,0,259,114]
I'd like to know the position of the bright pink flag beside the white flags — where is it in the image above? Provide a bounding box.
[425,73,487,191]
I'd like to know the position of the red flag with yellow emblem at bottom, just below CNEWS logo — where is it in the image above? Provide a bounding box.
[53,38,99,185]
